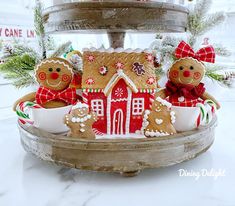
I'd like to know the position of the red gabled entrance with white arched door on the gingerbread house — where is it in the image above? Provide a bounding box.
[110,79,130,135]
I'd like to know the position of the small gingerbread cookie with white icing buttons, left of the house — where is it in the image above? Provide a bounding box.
[64,102,97,139]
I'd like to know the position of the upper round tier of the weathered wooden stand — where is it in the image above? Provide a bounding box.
[44,1,188,33]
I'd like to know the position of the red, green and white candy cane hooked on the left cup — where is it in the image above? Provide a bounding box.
[16,102,42,125]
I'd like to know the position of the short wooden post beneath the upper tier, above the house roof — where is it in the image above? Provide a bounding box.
[108,32,126,49]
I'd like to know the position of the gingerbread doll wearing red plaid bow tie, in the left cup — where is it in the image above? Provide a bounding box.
[14,58,78,109]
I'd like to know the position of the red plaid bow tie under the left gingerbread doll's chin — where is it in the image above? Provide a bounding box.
[35,87,77,105]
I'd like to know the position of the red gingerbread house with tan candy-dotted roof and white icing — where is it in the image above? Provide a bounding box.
[82,49,157,135]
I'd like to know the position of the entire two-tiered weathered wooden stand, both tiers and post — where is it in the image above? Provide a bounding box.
[19,1,216,176]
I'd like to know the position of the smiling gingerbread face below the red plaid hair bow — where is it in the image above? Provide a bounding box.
[168,57,205,86]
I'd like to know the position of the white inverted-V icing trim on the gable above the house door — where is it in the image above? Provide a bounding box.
[104,69,138,95]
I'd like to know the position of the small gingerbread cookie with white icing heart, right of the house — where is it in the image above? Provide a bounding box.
[141,97,176,137]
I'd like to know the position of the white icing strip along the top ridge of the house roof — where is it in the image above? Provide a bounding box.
[83,47,153,54]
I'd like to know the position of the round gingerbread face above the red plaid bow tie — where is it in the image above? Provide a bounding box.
[35,58,73,91]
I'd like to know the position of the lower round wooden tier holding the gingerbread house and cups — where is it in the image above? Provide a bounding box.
[19,118,217,176]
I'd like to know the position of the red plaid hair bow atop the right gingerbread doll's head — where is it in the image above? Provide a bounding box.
[175,41,215,63]
